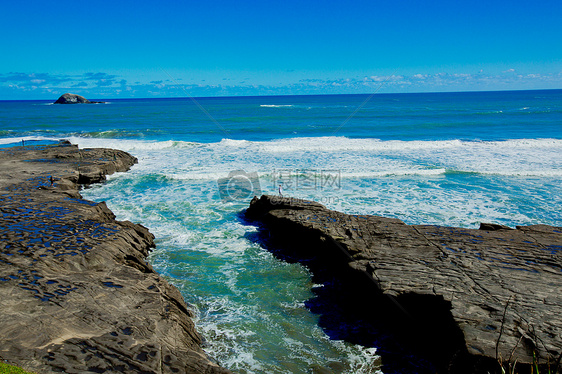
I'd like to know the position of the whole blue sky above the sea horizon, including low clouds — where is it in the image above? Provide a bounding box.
[0,0,562,100]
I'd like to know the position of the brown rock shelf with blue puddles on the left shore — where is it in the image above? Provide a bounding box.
[0,142,229,373]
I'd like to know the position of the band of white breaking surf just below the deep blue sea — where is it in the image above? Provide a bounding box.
[64,137,562,180]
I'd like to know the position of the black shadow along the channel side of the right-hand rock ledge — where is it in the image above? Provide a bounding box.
[239,213,446,374]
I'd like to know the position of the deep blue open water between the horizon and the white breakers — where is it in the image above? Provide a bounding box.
[0,90,562,143]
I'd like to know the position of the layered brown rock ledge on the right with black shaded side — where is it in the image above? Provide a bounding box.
[245,195,562,373]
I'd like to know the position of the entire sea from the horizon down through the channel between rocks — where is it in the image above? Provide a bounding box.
[0,90,562,373]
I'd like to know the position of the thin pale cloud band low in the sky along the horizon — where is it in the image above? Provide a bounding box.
[0,69,562,99]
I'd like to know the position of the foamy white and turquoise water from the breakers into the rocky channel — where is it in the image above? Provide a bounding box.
[79,133,562,373]
